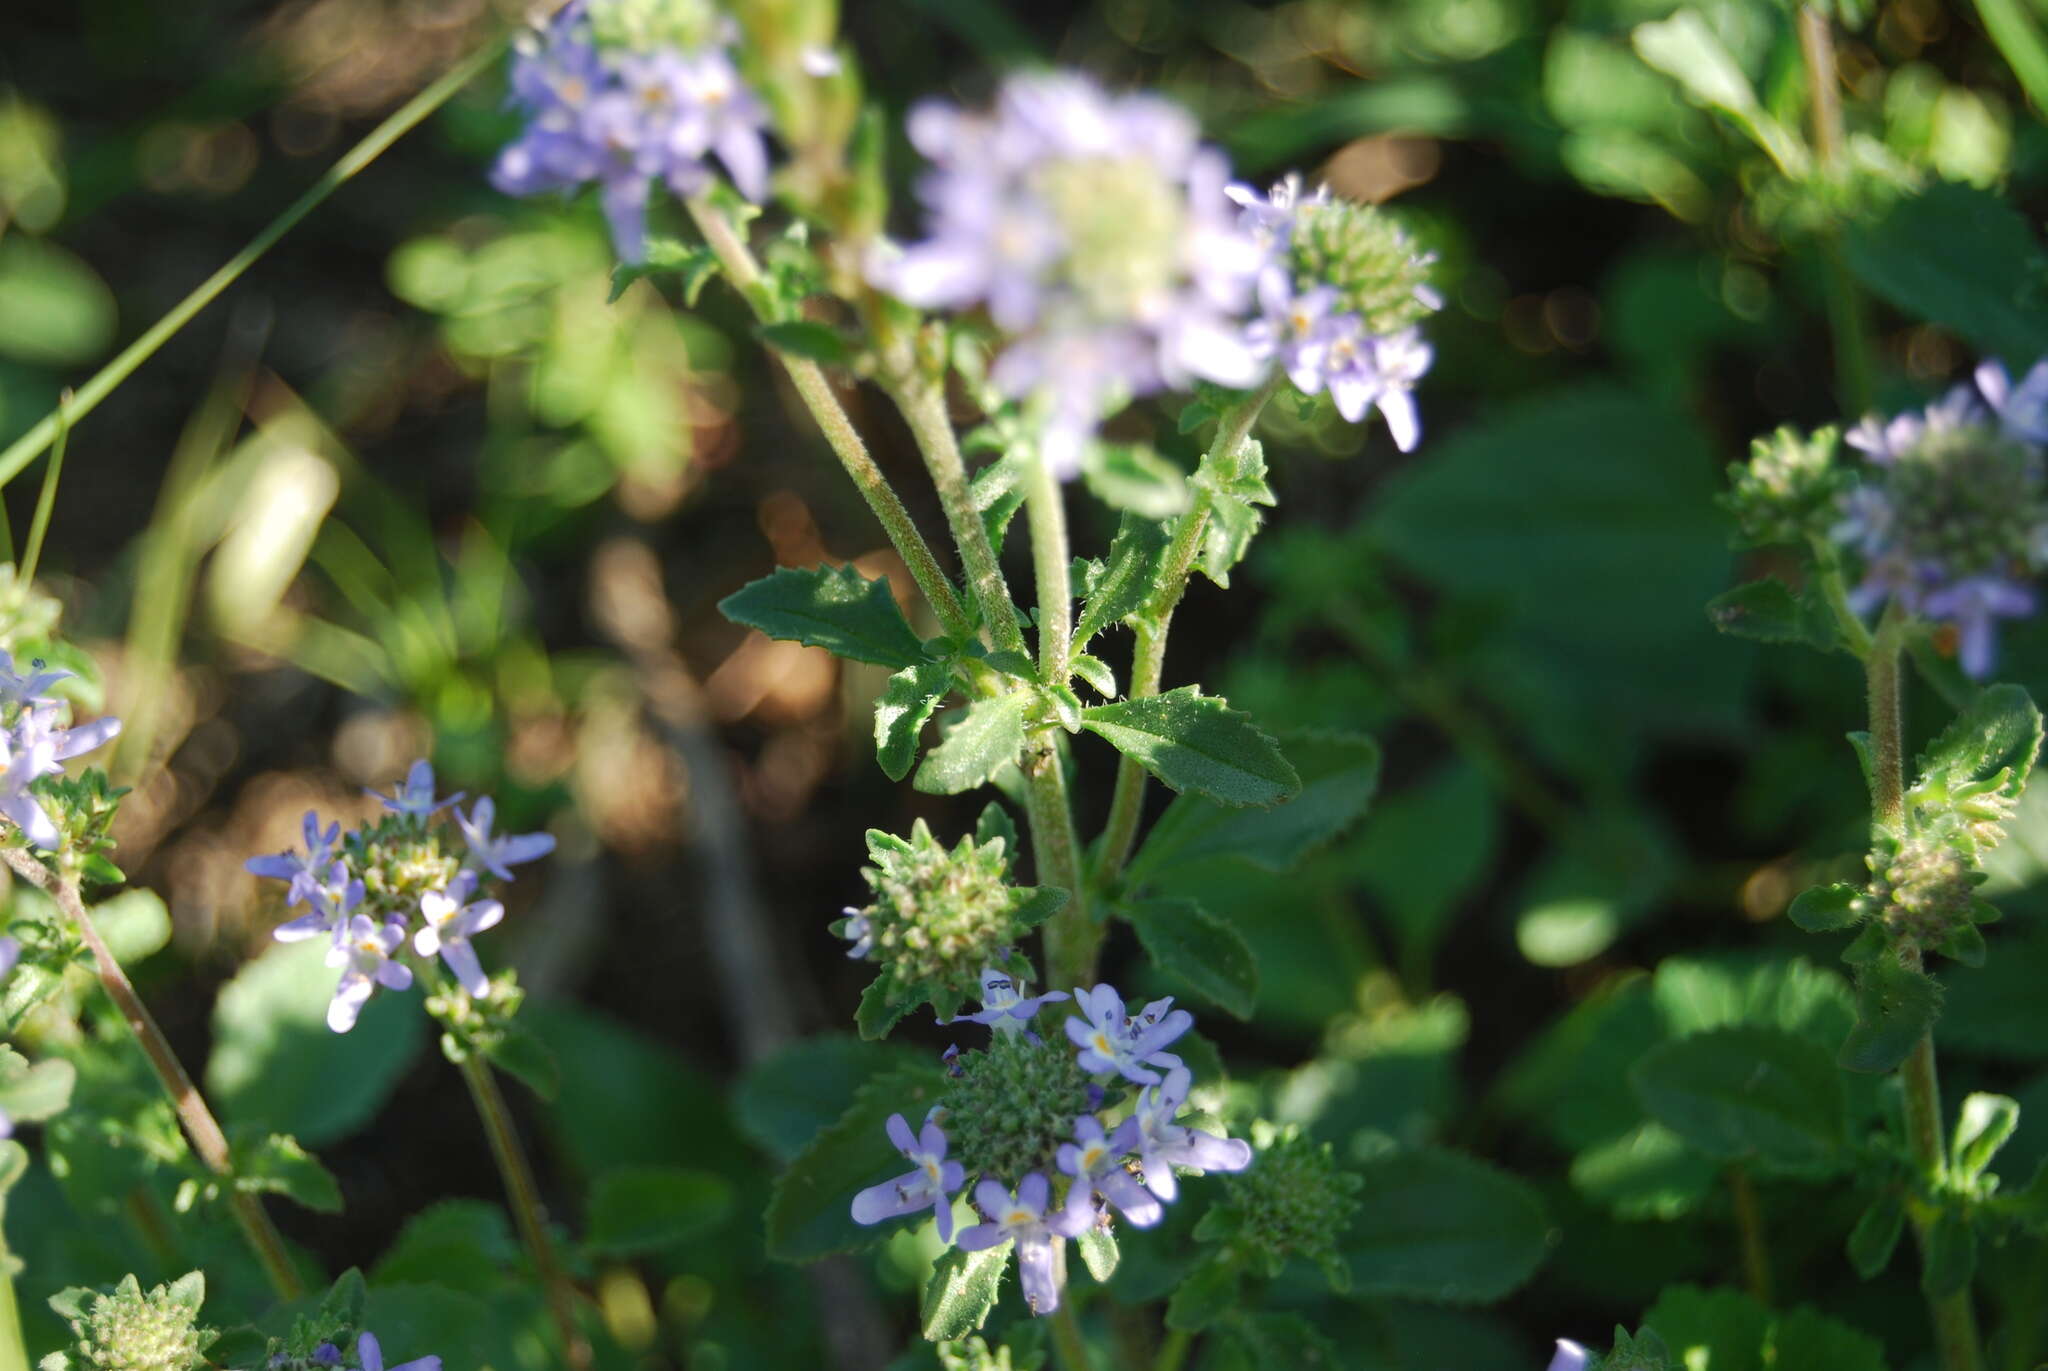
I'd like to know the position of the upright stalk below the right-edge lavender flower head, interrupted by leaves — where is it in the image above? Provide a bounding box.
[1864,618,1985,1371]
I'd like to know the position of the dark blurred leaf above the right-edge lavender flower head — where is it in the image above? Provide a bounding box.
[1843,180,2048,363]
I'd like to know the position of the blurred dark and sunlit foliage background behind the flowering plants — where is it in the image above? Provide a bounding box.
[0,0,2048,1371]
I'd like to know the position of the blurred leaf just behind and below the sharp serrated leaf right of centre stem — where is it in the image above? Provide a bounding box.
[1128,730,1380,885]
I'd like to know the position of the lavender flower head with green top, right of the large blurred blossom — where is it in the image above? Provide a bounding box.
[1229,176,1444,453]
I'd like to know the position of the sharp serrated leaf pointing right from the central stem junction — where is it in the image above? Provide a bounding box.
[1081,687,1300,805]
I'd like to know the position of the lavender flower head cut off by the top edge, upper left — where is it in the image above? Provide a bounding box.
[492,0,768,262]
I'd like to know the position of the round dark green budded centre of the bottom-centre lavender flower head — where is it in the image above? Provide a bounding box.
[940,1033,1094,1185]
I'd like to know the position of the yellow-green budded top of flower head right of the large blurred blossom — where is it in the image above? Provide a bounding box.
[1290,195,1436,338]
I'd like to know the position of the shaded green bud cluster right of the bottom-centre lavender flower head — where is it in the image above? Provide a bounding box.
[1194,1123,1364,1291]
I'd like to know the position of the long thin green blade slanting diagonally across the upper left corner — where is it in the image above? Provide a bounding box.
[0,39,510,497]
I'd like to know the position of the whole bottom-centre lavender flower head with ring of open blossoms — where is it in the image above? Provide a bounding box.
[852,969,1251,1314]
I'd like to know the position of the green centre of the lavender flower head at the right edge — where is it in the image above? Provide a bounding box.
[1882,424,2048,580]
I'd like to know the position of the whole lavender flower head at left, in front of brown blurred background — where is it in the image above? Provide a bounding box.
[246,760,555,1033]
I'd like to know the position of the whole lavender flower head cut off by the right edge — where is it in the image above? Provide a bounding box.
[1833,361,2048,678]
